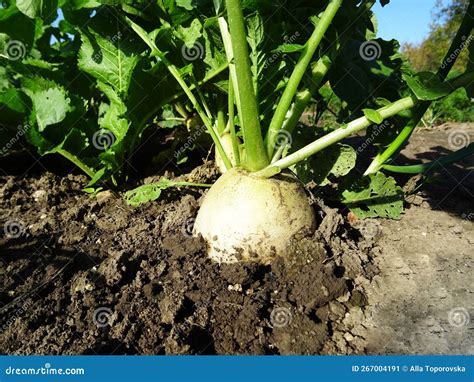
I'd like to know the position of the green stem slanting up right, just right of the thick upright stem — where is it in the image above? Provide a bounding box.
[266,0,342,157]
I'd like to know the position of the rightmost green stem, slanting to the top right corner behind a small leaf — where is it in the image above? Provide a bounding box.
[364,0,474,175]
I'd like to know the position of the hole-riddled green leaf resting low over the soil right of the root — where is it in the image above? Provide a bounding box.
[342,172,404,219]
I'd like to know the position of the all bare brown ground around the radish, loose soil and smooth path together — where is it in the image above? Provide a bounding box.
[0,124,474,354]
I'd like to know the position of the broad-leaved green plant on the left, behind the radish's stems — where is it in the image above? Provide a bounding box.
[0,0,227,186]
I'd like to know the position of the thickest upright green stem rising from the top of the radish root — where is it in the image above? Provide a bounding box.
[226,0,269,171]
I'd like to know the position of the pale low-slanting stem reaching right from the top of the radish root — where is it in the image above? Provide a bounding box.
[255,97,416,178]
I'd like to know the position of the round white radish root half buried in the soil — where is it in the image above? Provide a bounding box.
[194,169,316,264]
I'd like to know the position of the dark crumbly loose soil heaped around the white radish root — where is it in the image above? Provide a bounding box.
[0,163,377,354]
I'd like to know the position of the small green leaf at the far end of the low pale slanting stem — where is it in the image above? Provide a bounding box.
[403,72,453,101]
